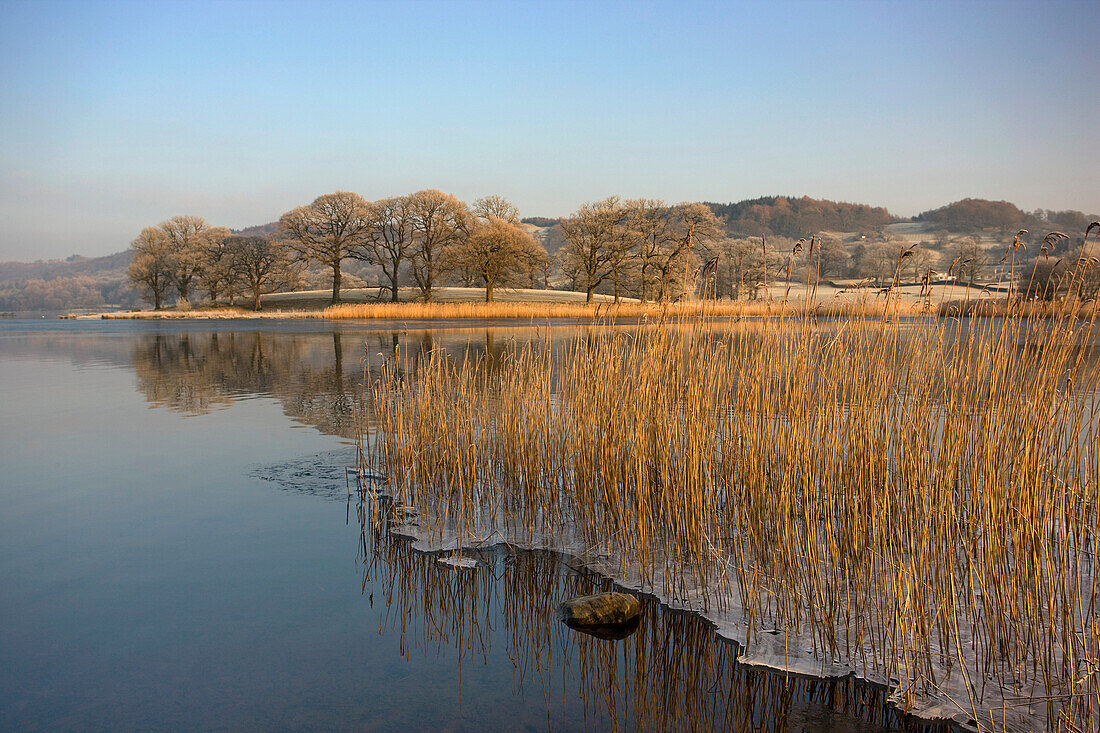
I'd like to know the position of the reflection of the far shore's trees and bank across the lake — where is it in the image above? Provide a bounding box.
[12,319,1098,438]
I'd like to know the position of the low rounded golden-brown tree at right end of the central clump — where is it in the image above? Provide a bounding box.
[450,215,549,303]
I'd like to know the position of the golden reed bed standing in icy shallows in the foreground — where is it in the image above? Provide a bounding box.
[361,299,1100,731]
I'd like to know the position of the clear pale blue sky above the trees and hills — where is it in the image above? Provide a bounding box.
[0,0,1100,260]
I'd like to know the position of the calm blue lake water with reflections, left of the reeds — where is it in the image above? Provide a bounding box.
[0,321,946,731]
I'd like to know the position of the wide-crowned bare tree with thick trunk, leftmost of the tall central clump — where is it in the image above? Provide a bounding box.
[278,190,373,304]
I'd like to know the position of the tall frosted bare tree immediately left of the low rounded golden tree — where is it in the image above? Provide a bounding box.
[408,189,470,302]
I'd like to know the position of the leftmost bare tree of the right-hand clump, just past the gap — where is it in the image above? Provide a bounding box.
[560,196,628,303]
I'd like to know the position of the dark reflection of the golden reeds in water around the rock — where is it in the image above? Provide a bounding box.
[358,500,952,732]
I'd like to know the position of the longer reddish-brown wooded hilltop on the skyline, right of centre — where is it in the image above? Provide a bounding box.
[705,196,899,238]
